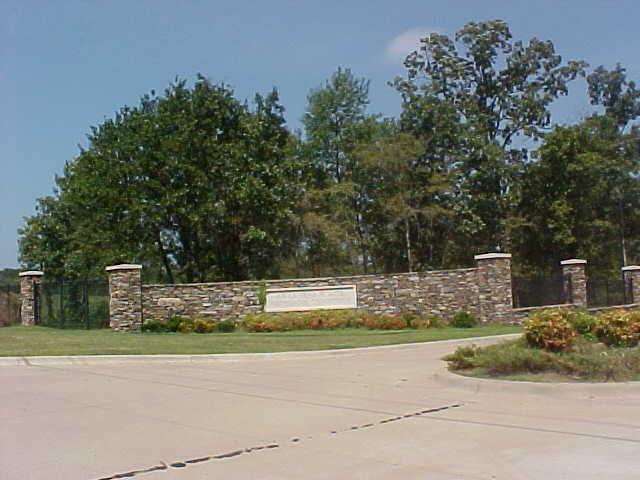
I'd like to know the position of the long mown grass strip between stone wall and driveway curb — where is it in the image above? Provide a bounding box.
[0,325,521,357]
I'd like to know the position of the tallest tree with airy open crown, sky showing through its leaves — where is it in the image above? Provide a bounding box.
[394,20,585,255]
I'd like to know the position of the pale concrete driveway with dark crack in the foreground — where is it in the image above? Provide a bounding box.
[0,339,640,480]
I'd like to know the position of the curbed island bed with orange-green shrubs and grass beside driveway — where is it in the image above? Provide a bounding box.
[444,310,640,382]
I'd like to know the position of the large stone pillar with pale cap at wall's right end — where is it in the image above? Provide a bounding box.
[474,253,513,323]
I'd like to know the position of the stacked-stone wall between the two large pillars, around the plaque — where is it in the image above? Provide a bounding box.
[142,268,480,321]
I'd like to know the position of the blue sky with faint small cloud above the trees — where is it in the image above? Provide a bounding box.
[0,0,640,268]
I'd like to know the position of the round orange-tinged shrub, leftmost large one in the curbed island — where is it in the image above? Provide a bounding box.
[524,309,576,352]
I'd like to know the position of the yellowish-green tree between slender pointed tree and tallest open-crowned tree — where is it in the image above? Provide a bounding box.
[359,133,452,272]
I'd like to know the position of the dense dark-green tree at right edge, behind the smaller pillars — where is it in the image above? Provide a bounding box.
[513,116,640,276]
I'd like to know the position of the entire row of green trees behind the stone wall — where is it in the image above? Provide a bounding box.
[20,20,640,282]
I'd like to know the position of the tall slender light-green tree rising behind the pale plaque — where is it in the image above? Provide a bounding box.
[302,68,386,274]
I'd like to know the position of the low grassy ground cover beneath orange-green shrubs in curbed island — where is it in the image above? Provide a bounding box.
[444,337,640,382]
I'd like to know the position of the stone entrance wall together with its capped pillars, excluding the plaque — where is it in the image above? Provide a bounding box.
[105,253,640,331]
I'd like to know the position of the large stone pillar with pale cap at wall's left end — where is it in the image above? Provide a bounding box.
[106,264,142,332]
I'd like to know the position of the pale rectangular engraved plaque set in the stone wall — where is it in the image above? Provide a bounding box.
[264,285,358,312]
